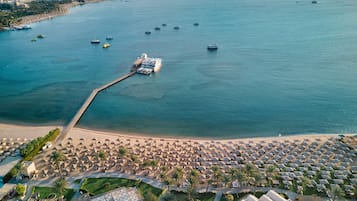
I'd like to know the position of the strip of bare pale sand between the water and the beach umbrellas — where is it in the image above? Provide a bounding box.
[0,123,355,142]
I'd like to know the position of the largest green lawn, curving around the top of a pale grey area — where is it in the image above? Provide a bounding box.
[80,177,162,198]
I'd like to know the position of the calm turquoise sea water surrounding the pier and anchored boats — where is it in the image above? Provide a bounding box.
[0,0,357,137]
